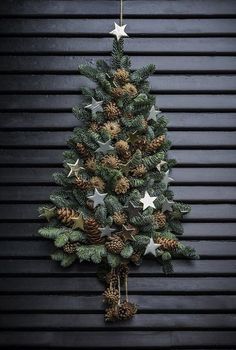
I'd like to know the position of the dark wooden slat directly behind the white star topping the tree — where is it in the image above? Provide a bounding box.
[0,18,236,36]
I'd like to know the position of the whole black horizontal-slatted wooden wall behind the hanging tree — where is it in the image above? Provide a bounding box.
[0,0,236,350]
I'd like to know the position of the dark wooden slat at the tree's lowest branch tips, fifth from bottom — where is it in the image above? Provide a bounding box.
[0,260,236,276]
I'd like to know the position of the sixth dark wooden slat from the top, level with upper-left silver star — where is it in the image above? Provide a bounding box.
[0,93,236,112]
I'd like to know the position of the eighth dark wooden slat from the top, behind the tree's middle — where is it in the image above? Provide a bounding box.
[0,131,236,148]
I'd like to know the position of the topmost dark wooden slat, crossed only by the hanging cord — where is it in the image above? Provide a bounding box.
[0,0,236,17]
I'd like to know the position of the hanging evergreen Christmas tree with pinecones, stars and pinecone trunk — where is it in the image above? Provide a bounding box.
[39,0,197,321]
